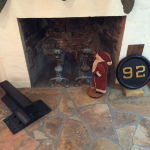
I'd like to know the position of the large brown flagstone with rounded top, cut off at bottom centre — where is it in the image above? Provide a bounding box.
[57,118,91,150]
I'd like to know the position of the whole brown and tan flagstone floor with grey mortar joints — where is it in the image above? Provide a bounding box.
[0,86,150,150]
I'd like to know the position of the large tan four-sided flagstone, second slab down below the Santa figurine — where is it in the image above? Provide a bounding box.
[77,104,114,136]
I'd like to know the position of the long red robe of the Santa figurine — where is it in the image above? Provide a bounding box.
[92,62,108,93]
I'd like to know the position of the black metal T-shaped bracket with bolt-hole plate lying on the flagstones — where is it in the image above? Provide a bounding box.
[0,81,52,134]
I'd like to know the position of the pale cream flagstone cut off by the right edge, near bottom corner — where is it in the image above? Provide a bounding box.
[133,118,150,146]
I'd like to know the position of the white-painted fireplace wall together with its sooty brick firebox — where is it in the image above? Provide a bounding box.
[0,0,150,87]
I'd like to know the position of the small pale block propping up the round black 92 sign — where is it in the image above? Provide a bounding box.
[122,87,144,97]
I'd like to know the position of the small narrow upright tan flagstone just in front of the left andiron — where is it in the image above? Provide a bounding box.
[59,92,74,116]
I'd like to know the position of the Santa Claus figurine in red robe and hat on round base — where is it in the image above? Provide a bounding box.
[88,52,112,98]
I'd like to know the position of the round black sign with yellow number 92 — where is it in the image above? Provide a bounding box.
[116,55,150,89]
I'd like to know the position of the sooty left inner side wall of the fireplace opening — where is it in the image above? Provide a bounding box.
[18,19,47,86]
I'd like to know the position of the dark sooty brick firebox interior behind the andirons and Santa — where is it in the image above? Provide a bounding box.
[18,16,126,87]
